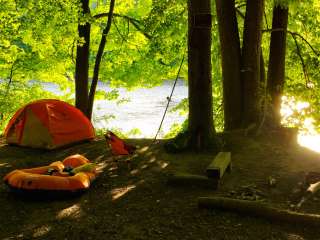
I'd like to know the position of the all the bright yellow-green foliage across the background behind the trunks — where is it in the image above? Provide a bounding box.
[0,0,320,137]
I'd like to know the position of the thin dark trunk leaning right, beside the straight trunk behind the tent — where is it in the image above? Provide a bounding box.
[87,0,115,119]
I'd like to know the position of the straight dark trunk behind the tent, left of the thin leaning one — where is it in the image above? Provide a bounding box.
[75,0,90,115]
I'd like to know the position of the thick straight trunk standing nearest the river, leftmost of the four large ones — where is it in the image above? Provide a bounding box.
[188,0,214,150]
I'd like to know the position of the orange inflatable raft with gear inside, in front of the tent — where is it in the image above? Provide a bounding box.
[4,154,96,193]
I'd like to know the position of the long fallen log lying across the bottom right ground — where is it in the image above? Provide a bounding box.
[198,197,320,226]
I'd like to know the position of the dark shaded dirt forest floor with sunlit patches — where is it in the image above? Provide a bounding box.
[0,133,320,240]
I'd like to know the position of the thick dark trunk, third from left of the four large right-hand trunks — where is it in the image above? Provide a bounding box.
[241,0,264,127]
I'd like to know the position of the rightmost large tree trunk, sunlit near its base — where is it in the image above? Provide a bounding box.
[267,5,288,126]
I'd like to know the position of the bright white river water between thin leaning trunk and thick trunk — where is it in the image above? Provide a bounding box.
[93,81,188,138]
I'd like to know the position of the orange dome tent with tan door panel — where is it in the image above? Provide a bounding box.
[4,99,95,149]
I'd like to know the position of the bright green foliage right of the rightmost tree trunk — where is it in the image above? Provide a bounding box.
[286,1,320,129]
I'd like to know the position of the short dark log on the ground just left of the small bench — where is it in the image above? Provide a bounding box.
[167,173,219,189]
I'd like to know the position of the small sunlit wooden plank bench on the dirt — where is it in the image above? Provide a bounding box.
[207,152,231,179]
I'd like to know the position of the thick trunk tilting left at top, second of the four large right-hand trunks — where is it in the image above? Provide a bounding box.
[216,0,242,130]
